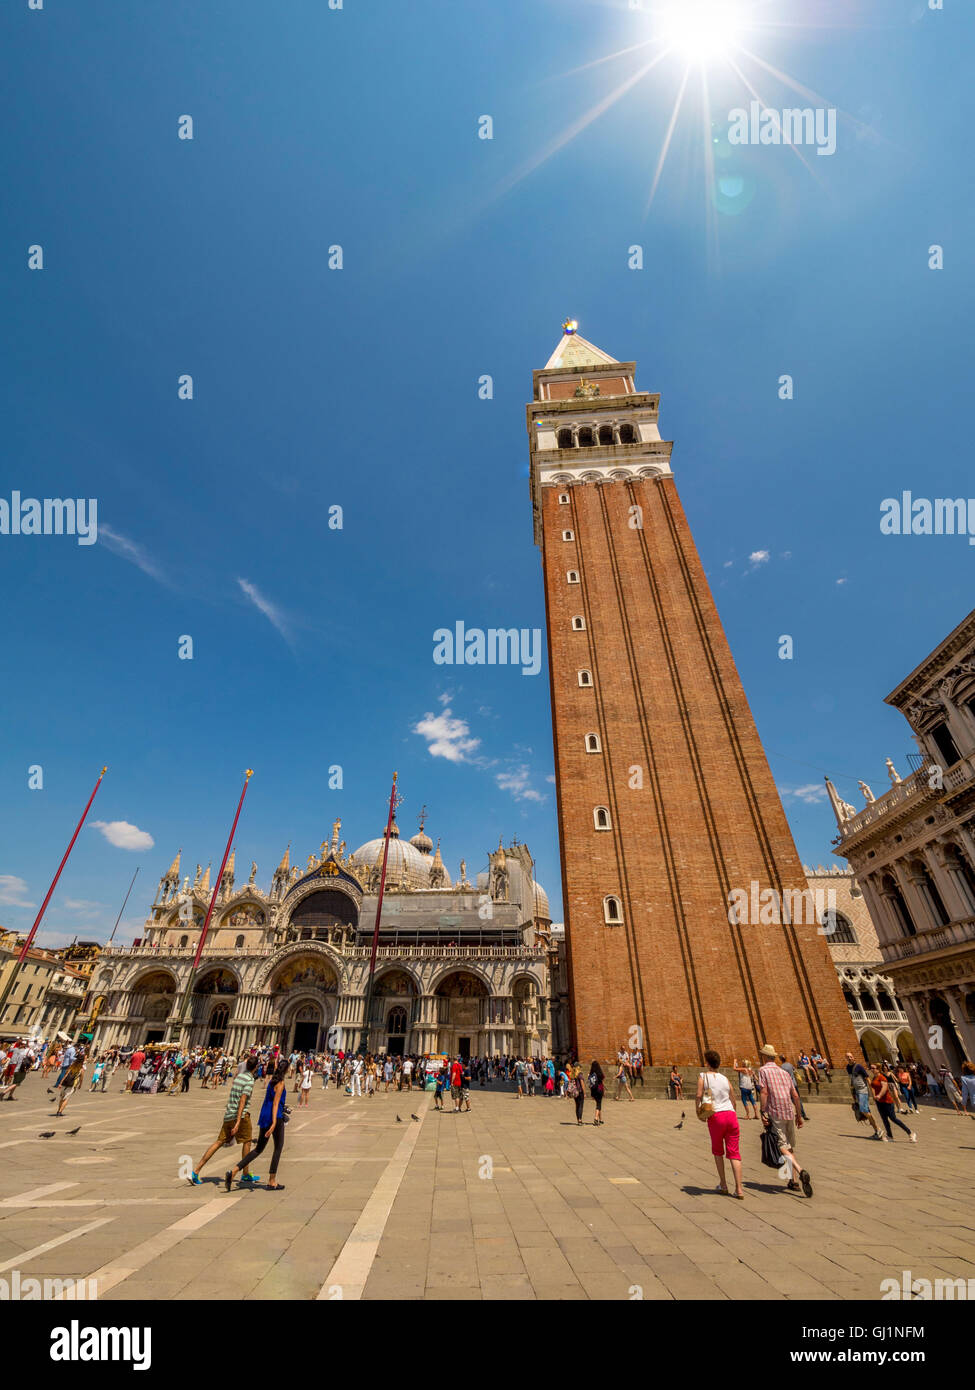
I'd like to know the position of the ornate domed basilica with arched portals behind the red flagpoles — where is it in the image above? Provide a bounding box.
[89,816,567,1055]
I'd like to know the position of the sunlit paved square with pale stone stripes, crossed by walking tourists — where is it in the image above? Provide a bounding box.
[0,1073,975,1300]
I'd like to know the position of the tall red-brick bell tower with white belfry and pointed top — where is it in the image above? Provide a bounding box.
[527,321,860,1066]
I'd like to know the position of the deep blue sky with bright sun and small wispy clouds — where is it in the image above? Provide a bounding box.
[0,0,975,944]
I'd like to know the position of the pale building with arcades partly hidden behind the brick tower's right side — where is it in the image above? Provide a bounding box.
[803,865,919,1066]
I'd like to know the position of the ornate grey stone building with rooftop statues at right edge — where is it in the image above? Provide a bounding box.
[826,612,975,1072]
